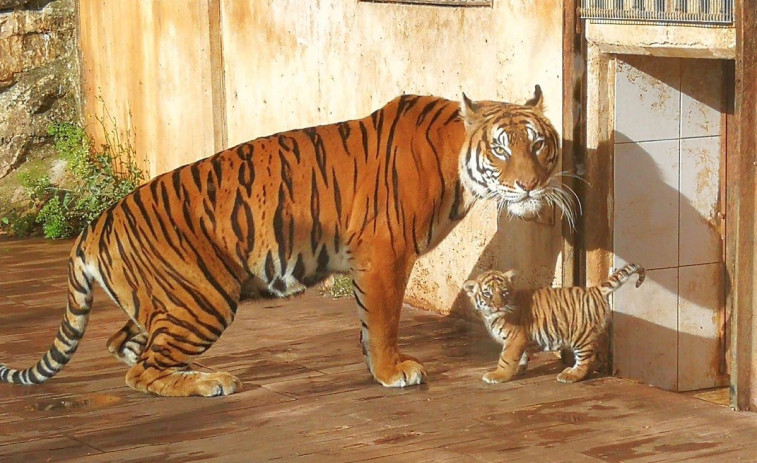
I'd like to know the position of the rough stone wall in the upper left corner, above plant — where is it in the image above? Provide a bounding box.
[0,0,81,178]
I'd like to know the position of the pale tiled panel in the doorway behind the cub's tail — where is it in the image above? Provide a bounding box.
[610,55,733,391]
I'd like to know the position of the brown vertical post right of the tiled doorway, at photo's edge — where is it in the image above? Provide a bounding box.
[726,0,757,411]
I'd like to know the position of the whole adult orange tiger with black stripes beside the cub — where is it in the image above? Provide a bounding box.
[0,86,572,396]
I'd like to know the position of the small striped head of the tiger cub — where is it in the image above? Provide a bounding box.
[463,270,515,315]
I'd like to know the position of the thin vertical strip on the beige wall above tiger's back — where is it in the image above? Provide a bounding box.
[208,0,228,152]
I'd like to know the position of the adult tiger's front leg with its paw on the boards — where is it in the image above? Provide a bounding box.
[353,250,426,387]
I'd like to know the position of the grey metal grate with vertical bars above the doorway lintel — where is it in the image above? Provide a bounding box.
[581,0,733,25]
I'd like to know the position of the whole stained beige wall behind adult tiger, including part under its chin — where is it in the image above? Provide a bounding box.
[81,0,562,312]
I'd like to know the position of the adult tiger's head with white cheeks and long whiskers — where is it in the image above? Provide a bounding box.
[460,85,575,224]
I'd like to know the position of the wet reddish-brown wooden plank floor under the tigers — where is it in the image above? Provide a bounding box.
[0,238,757,463]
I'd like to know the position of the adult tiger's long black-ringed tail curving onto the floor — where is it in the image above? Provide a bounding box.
[0,245,93,385]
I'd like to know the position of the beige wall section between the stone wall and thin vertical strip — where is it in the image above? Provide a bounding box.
[79,0,219,176]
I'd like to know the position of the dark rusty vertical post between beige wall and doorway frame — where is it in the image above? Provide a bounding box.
[562,0,583,286]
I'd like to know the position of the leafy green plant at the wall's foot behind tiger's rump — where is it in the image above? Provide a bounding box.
[0,113,144,238]
